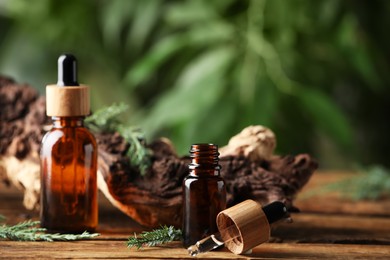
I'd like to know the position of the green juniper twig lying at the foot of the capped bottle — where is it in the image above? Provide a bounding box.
[0,219,99,242]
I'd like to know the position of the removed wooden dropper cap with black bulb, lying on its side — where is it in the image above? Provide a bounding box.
[217,200,288,254]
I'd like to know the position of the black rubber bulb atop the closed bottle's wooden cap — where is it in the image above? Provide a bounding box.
[57,54,79,87]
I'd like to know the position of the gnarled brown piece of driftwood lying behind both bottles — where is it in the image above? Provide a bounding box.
[0,77,317,227]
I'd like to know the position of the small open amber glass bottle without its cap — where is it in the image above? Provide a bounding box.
[183,144,226,247]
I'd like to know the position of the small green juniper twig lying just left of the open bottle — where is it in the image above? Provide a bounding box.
[127,226,182,249]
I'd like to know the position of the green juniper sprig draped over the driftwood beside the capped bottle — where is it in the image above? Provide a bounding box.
[85,103,151,175]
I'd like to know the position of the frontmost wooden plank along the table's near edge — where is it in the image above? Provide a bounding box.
[0,240,390,259]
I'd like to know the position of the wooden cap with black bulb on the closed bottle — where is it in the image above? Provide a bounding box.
[46,54,90,117]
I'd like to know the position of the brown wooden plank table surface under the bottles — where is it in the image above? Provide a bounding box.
[0,172,390,259]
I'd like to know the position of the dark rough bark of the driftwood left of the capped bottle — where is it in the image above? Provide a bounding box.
[0,77,49,159]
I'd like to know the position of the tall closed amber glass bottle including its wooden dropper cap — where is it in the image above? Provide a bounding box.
[40,54,98,233]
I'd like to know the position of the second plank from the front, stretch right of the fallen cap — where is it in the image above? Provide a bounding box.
[271,213,390,245]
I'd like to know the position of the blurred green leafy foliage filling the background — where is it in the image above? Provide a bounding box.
[0,0,390,168]
